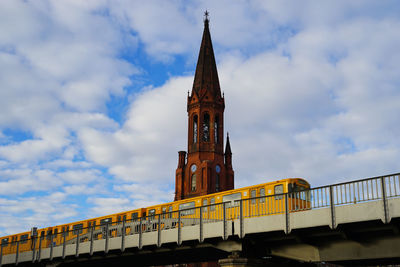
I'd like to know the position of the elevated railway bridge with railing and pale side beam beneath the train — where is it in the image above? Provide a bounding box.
[0,173,400,267]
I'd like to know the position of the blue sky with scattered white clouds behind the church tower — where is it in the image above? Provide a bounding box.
[0,0,400,235]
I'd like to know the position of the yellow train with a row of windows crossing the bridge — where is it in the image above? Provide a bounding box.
[1,178,311,255]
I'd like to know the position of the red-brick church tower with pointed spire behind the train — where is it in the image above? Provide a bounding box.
[175,12,234,200]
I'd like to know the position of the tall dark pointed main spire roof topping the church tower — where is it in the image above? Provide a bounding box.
[192,11,221,97]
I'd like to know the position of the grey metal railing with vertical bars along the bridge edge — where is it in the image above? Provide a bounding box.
[0,173,400,266]
